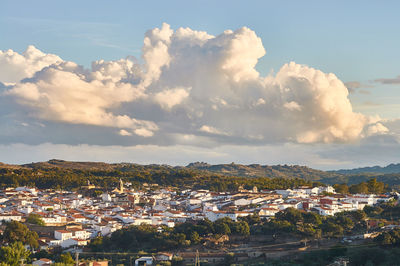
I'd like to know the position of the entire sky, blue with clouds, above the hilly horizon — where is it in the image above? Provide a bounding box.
[0,0,400,170]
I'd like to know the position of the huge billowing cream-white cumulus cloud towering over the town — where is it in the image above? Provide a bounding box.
[0,24,389,145]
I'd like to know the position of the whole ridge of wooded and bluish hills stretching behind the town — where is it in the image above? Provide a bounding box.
[0,160,400,191]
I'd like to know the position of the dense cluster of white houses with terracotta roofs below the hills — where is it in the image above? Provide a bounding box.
[0,181,391,249]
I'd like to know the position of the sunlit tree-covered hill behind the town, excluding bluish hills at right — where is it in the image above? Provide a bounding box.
[0,162,319,191]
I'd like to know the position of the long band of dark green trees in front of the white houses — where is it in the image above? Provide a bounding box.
[87,204,390,252]
